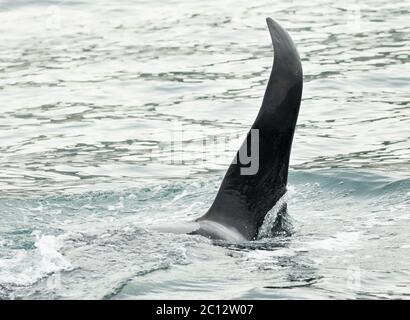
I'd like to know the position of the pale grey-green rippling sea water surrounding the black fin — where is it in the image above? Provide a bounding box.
[0,0,410,299]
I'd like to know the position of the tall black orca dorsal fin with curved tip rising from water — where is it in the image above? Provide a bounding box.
[196,18,303,240]
